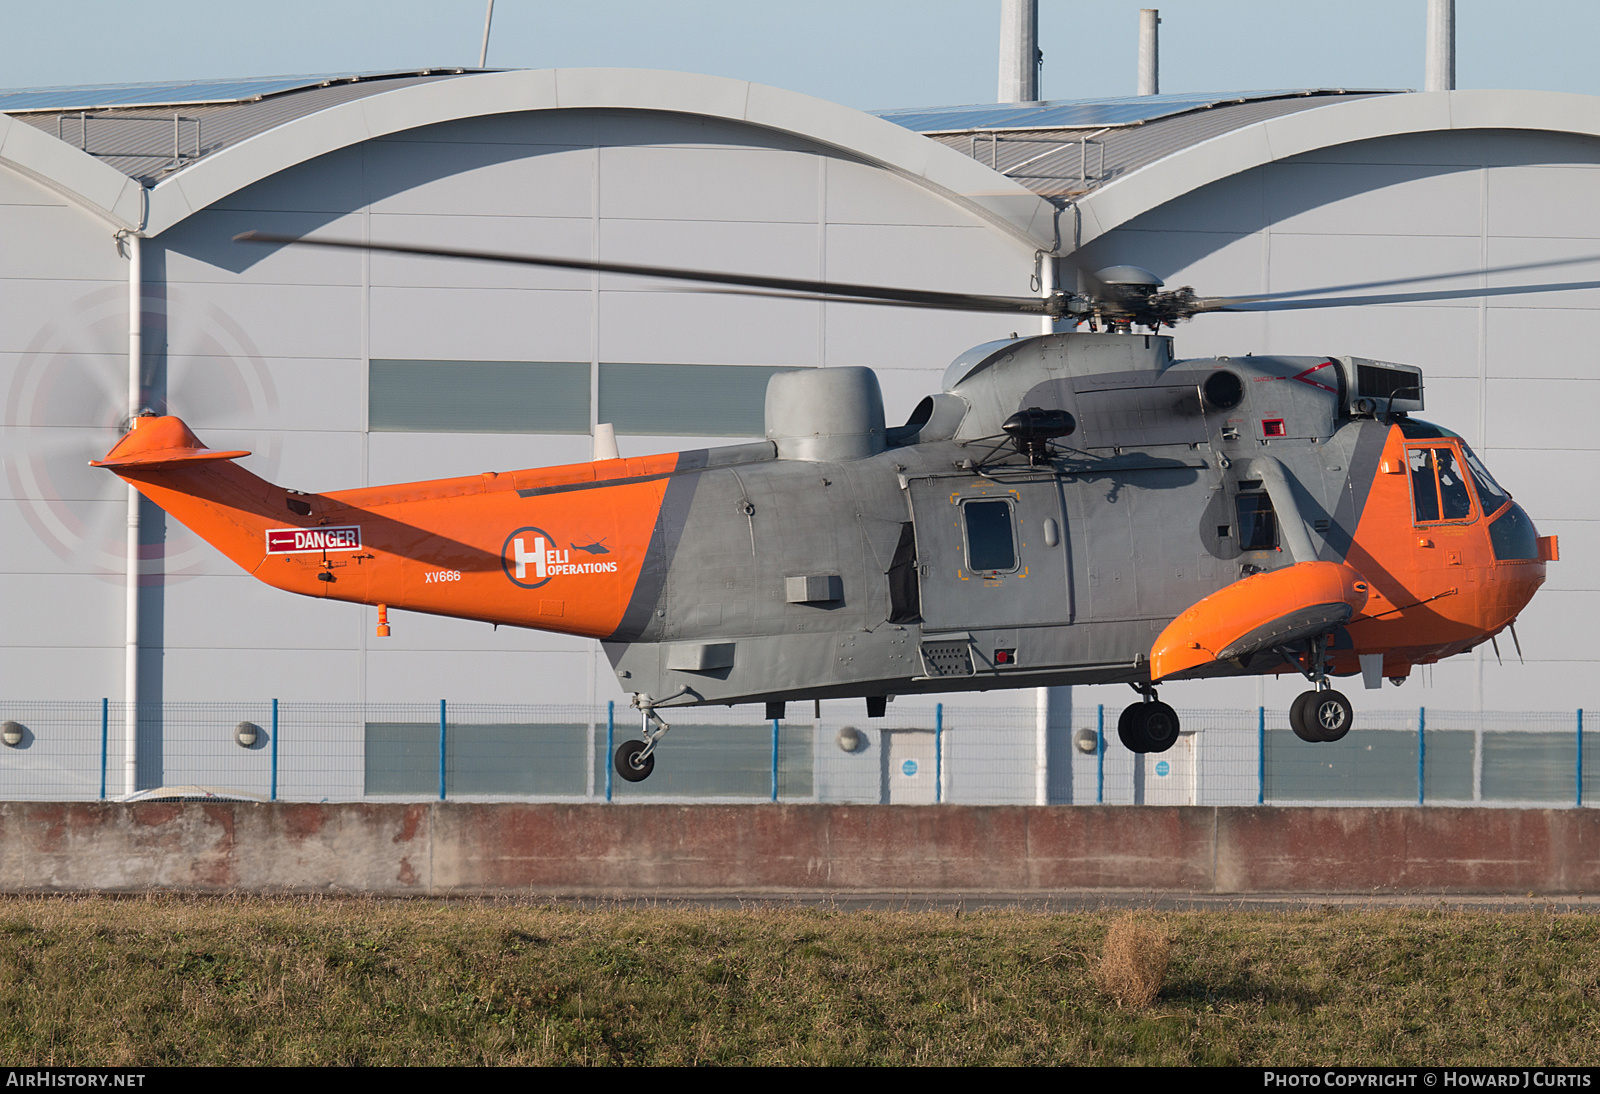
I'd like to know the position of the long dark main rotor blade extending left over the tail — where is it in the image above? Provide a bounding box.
[234,232,1046,315]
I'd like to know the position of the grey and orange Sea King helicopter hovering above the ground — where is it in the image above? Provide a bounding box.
[84,232,1561,782]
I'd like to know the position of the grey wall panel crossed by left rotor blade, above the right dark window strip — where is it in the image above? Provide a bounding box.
[600,218,822,284]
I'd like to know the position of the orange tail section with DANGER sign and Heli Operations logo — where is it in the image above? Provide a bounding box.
[94,417,678,638]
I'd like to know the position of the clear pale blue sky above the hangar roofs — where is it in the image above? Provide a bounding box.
[9,0,1600,110]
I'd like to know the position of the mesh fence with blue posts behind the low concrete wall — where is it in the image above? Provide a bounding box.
[0,701,1600,806]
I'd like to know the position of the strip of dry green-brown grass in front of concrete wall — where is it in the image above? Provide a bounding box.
[0,896,1600,1067]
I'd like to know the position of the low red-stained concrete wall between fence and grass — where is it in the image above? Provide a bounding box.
[0,803,1600,896]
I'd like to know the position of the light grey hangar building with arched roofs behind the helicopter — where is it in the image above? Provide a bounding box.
[0,69,1600,793]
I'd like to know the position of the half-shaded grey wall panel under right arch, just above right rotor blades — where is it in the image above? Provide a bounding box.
[1267,163,1480,237]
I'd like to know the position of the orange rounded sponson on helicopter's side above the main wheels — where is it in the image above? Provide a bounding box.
[1150,561,1368,680]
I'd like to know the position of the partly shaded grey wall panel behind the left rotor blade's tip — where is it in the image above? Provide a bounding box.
[158,208,363,285]
